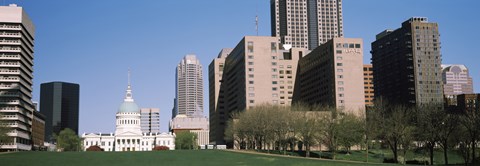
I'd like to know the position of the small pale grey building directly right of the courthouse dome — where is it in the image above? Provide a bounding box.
[140,108,160,133]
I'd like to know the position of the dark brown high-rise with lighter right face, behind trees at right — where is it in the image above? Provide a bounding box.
[371,17,443,106]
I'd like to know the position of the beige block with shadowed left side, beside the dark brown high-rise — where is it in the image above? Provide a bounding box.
[294,38,365,115]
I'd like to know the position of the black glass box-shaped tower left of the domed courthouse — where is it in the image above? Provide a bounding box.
[40,82,80,142]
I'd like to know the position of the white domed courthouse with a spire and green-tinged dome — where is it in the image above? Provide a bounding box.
[82,78,175,151]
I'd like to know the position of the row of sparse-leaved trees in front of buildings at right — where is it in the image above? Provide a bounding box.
[225,99,480,164]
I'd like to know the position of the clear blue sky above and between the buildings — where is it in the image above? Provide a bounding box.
[12,0,480,133]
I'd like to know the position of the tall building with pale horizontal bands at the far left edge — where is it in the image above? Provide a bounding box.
[0,4,35,151]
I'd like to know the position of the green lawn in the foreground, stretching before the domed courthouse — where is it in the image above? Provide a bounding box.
[0,150,394,166]
